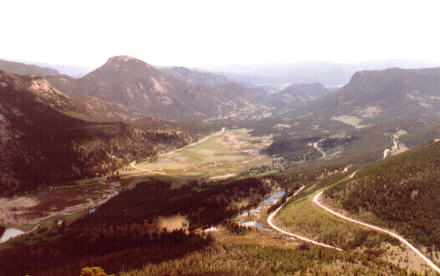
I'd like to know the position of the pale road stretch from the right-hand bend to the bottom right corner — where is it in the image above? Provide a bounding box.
[313,191,440,273]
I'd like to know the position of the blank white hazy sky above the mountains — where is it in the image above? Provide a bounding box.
[0,0,440,66]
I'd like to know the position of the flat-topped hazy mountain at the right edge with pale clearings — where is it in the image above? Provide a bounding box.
[285,68,440,130]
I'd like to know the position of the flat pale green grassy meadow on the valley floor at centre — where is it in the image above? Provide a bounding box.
[132,129,272,179]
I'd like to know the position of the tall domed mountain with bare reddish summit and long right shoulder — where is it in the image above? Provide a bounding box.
[47,56,268,121]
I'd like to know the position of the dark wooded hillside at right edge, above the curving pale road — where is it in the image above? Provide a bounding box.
[325,140,440,249]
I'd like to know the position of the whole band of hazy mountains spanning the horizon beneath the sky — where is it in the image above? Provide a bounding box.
[0,56,440,127]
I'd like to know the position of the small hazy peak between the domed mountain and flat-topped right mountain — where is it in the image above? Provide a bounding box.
[269,83,329,111]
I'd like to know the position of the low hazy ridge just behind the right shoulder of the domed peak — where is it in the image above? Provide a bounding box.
[158,67,229,86]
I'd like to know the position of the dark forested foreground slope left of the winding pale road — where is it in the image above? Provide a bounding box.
[0,169,404,275]
